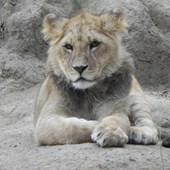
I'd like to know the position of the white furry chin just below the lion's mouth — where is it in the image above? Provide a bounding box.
[72,80,96,89]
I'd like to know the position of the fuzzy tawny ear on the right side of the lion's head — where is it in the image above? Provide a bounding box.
[100,8,127,32]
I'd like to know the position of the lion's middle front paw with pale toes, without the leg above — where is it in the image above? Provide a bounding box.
[91,126,128,147]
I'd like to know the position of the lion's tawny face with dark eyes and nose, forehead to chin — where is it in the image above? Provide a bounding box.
[44,10,127,89]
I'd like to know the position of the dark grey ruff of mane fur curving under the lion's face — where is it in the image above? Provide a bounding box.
[50,55,133,117]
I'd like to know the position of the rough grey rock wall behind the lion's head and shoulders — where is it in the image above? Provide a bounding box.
[0,0,170,93]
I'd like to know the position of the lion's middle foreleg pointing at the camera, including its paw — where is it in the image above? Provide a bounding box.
[91,113,130,147]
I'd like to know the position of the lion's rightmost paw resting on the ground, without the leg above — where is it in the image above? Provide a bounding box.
[129,126,158,145]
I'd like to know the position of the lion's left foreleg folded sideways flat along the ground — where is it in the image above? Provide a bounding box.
[35,114,96,145]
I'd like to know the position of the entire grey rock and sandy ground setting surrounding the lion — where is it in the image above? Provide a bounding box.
[0,0,170,170]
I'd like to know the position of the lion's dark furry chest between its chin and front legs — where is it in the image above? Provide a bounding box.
[62,73,131,120]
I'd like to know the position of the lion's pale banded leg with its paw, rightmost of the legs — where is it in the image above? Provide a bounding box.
[129,96,158,145]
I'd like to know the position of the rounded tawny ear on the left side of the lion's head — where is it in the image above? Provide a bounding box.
[42,14,68,41]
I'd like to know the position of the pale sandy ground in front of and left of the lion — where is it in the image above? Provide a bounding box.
[0,87,170,170]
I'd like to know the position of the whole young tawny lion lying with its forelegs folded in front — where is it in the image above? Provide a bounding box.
[34,10,158,147]
